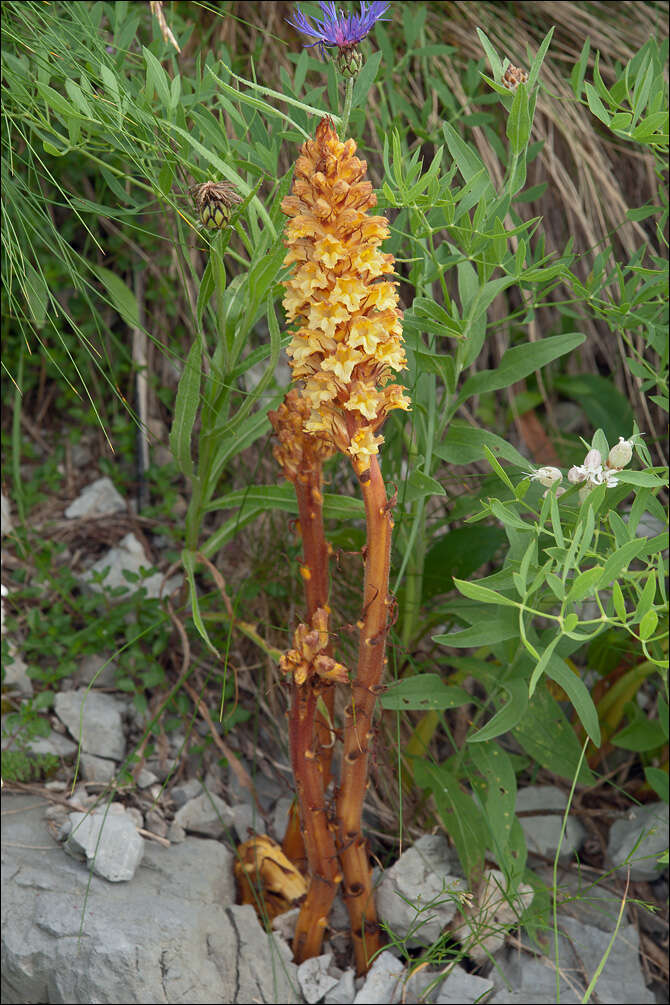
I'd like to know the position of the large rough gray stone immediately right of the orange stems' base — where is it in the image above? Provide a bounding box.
[376,834,465,946]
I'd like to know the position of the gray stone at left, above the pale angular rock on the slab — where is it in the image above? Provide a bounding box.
[53,687,126,761]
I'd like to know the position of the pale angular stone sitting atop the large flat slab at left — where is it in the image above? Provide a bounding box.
[61,807,145,882]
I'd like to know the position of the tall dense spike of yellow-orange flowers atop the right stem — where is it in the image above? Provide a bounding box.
[282,119,410,472]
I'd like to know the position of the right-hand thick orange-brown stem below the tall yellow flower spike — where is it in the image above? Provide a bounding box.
[337,455,393,974]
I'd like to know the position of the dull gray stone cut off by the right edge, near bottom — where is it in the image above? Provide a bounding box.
[607,803,668,880]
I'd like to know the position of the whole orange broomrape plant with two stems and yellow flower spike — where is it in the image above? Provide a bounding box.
[271,119,410,972]
